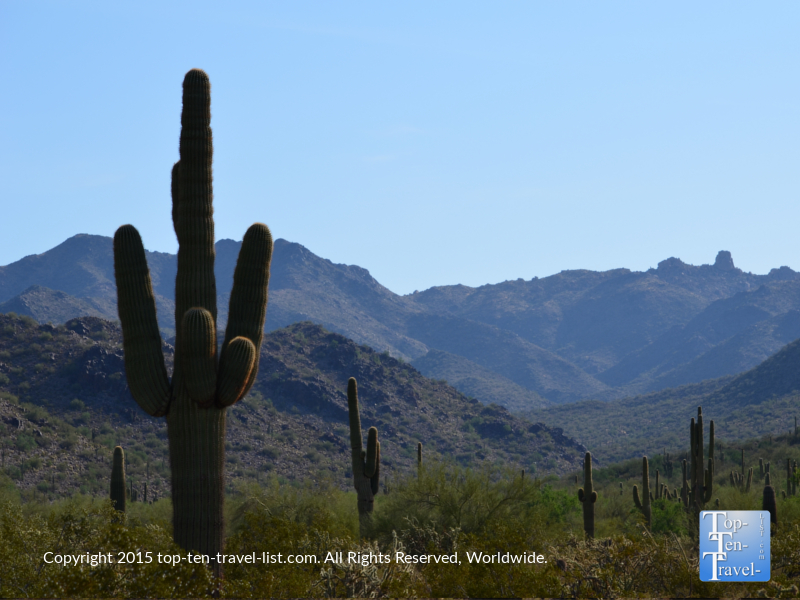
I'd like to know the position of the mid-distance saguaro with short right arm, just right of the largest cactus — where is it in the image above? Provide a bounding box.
[347,377,381,537]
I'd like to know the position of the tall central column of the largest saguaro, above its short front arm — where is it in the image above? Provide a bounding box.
[173,69,217,344]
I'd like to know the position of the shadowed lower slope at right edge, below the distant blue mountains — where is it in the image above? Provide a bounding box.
[527,340,800,462]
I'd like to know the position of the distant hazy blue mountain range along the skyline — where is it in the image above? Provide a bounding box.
[0,235,800,410]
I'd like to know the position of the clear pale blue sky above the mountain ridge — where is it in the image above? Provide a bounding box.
[0,0,800,294]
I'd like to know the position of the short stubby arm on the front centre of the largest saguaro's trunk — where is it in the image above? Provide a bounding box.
[180,308,217,408]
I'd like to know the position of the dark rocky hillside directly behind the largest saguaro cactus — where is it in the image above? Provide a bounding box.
[0,315,584,502]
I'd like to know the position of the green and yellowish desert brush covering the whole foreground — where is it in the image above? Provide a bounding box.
[0,439,800,597]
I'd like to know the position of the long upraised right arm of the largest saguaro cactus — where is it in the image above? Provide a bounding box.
[220,223,273,396]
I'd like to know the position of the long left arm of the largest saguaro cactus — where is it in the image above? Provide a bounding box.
[114,225,170,417]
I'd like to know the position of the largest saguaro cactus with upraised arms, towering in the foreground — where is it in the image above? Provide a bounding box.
[114,69,272,573]
